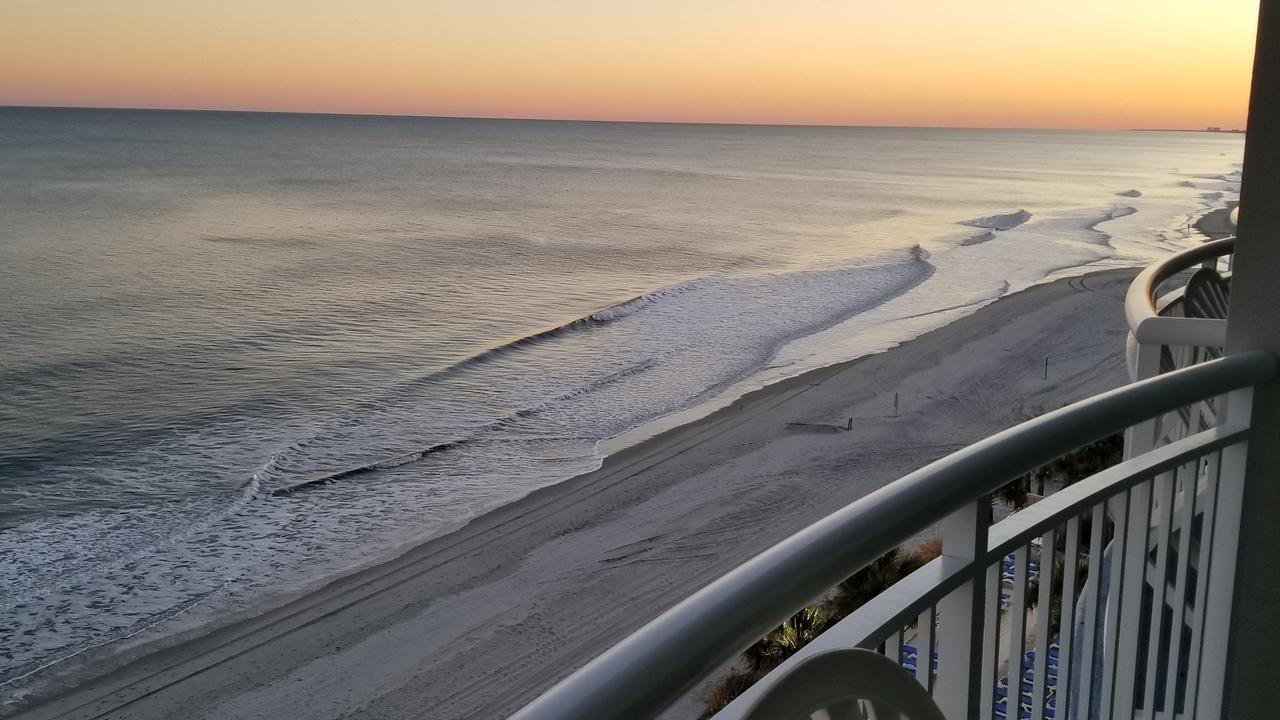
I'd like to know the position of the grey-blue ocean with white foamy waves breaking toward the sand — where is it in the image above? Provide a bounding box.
[0,108,1243,701]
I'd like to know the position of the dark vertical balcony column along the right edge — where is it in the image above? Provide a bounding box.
[1208,0,1280,717]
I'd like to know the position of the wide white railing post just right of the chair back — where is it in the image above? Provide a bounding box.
[936,497,991,720]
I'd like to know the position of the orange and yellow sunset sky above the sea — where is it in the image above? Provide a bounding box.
[0,0,1257,128]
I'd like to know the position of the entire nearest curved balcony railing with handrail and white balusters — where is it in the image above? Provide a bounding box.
[516,351,1276,720]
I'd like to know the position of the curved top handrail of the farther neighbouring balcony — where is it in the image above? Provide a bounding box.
[1124,237,1235,347]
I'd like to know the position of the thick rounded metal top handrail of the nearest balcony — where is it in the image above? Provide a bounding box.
[513,351,1276,720]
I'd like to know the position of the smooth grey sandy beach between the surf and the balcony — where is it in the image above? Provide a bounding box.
[10,270,1134,719]
